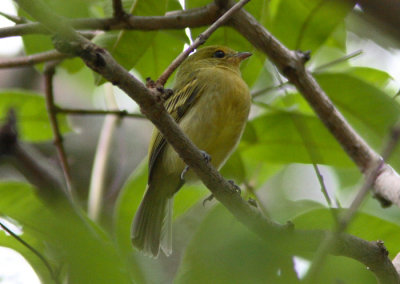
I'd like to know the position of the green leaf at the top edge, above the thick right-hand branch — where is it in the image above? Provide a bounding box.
[271,0,352,53]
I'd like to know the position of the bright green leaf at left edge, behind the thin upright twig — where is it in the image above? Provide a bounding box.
[0,90,69,142]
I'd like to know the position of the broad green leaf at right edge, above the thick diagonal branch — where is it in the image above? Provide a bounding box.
[315,72,400,141]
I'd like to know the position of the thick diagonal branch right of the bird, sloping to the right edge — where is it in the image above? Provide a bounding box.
[229,3,400,207]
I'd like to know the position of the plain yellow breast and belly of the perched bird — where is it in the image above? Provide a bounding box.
[180,69,250,168]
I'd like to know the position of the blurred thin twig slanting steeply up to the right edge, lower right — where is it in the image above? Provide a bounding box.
[306,124,400,283]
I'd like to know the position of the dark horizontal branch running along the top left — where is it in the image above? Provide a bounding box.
[0,4,220,38]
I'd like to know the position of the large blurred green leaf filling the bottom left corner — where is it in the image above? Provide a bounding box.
[0,183,131,283]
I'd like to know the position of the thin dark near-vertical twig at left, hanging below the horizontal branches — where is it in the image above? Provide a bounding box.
[44,64,74,199]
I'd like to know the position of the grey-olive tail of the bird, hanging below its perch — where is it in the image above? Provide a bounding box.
[131,185,173,257]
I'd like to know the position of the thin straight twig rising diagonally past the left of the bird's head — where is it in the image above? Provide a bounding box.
[156,0,250,86]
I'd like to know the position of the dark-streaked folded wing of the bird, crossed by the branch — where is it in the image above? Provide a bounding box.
[148,78,201,182]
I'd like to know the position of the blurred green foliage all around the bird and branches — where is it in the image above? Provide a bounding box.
[0,0,400,283]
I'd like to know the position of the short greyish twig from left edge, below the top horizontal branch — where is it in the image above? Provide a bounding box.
[0,50,71,68]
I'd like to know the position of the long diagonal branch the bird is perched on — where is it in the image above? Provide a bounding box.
[15,0,398,283]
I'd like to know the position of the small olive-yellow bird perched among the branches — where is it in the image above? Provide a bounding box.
[131,46,252,258]
